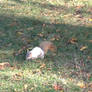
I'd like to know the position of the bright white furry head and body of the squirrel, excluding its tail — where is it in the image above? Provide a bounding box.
[26,47,44,60]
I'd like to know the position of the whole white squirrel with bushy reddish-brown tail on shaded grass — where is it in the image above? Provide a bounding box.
[26,41,57,60]
